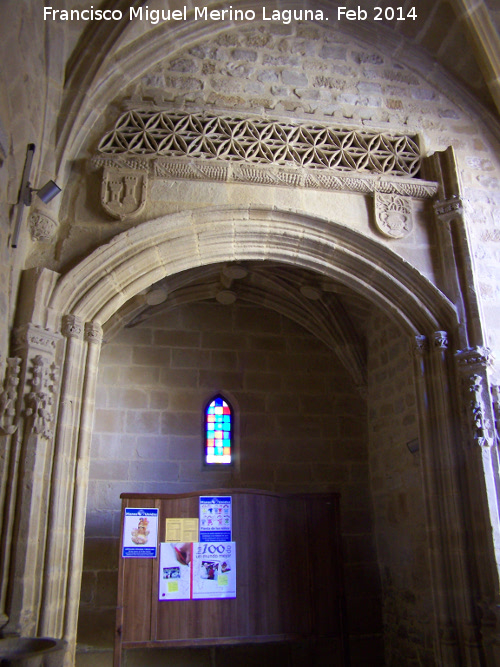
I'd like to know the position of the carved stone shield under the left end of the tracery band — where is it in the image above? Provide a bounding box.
[101,169,148,220]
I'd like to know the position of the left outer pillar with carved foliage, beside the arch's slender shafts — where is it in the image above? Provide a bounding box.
[2,324,61,636]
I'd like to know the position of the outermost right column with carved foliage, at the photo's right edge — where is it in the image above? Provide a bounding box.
[455,347,500,666]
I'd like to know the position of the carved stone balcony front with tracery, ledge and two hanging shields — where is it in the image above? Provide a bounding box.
[92,109,437,215]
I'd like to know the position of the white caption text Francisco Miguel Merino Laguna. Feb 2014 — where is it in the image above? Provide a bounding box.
[43,5,417,25]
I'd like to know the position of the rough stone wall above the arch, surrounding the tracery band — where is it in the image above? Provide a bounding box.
[61,22,500,378]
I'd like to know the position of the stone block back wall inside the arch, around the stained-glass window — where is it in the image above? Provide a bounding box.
[79,302,381,665]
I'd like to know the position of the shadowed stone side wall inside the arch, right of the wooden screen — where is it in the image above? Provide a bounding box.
[368,314,434,667]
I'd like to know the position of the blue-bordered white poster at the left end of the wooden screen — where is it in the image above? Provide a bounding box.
[122,507,158,558]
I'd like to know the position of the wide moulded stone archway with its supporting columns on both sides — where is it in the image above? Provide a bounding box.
[0,208,497,666]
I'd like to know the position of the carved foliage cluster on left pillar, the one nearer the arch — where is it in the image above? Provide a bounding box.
[24,355,59,439]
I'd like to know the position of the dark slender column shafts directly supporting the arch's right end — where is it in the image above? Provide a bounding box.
[415,331,484,667]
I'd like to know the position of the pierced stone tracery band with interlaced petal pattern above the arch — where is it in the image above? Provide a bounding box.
[98,110,421,177]
